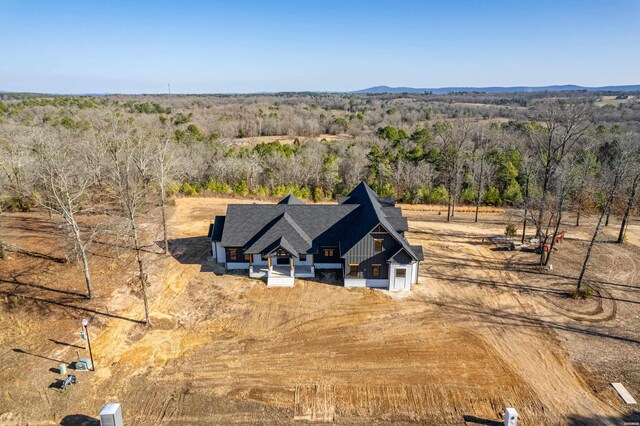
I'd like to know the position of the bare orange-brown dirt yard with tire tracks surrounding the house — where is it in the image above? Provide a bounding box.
[0,198,640,425]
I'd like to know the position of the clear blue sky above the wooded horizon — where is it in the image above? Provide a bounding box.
[0,0,640,93]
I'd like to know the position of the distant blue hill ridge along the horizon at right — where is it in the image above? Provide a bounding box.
[351,84,640,95]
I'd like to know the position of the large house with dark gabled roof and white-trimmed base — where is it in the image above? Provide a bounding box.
[209,182,423,290]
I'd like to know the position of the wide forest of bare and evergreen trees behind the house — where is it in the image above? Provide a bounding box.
[0,91,640,310]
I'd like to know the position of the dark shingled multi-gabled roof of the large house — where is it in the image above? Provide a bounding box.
[220,182,421,260]
